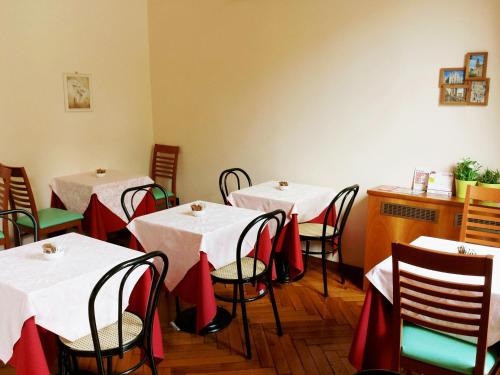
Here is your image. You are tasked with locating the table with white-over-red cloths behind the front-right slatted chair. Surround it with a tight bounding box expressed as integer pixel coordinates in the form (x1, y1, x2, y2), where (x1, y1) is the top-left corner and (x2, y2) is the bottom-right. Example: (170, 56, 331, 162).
(349, 236, 500, 370)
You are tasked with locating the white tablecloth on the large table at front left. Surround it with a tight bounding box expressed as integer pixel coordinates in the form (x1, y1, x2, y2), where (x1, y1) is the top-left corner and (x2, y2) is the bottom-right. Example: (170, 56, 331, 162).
(0, 233, 144, 363)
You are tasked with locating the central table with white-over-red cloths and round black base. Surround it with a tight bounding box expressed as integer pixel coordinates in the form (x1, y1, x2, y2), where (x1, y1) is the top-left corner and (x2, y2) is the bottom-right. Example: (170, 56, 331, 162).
(127, 201, 271, 334)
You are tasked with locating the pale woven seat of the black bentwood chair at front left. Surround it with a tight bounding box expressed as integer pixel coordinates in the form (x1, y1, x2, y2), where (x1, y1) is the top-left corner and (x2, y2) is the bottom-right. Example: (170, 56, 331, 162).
(59, 311, 143, 352)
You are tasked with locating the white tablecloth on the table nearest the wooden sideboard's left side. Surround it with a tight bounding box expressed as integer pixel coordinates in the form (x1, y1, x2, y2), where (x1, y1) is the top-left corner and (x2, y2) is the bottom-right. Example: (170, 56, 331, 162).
(228, 181, 335, 223)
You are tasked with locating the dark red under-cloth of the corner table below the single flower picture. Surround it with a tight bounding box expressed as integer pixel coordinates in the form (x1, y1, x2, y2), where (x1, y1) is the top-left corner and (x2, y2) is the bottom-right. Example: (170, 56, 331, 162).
(50, 192, 156, 241)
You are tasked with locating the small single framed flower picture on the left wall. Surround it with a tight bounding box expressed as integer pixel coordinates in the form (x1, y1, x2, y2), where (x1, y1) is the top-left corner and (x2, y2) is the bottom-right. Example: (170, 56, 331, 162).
(64, 73, 92, 112)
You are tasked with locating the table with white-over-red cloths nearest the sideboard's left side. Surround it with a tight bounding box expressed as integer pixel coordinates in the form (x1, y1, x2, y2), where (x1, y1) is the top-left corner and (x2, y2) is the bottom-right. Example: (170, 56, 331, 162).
(227, 181, 336, 281)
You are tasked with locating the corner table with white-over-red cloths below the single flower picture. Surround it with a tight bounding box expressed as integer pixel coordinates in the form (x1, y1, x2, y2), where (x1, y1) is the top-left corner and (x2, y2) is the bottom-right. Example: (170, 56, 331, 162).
(50, 169, 156, 241)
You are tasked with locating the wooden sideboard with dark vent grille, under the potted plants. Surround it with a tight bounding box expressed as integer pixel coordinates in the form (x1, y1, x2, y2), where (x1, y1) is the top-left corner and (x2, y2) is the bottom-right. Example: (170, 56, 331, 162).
(364, 186, 464, 288)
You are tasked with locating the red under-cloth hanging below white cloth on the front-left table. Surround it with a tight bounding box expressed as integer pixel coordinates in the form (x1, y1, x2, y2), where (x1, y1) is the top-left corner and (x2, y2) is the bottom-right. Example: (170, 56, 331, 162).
(8, 272, 163, 375)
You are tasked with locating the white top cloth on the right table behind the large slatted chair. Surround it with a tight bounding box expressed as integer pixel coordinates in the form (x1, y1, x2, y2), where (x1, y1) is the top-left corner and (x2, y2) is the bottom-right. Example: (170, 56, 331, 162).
(366, 236, 500, 345)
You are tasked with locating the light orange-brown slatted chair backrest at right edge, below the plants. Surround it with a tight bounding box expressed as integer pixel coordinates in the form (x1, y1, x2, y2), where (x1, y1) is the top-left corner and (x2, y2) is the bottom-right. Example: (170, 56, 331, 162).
(460, 186, 500, 247)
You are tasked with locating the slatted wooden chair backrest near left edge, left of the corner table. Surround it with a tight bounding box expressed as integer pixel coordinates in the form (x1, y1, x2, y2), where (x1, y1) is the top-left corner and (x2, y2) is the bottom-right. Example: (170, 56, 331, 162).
(7, 167, 39, 223)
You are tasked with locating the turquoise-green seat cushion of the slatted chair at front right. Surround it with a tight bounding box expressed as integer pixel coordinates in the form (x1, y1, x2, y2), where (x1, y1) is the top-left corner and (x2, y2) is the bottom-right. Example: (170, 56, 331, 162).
(401, 322, 500, 374)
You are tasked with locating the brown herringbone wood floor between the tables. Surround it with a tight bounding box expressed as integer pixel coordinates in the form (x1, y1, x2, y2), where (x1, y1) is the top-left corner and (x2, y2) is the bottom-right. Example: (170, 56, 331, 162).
(0, 262, 364, 375)
